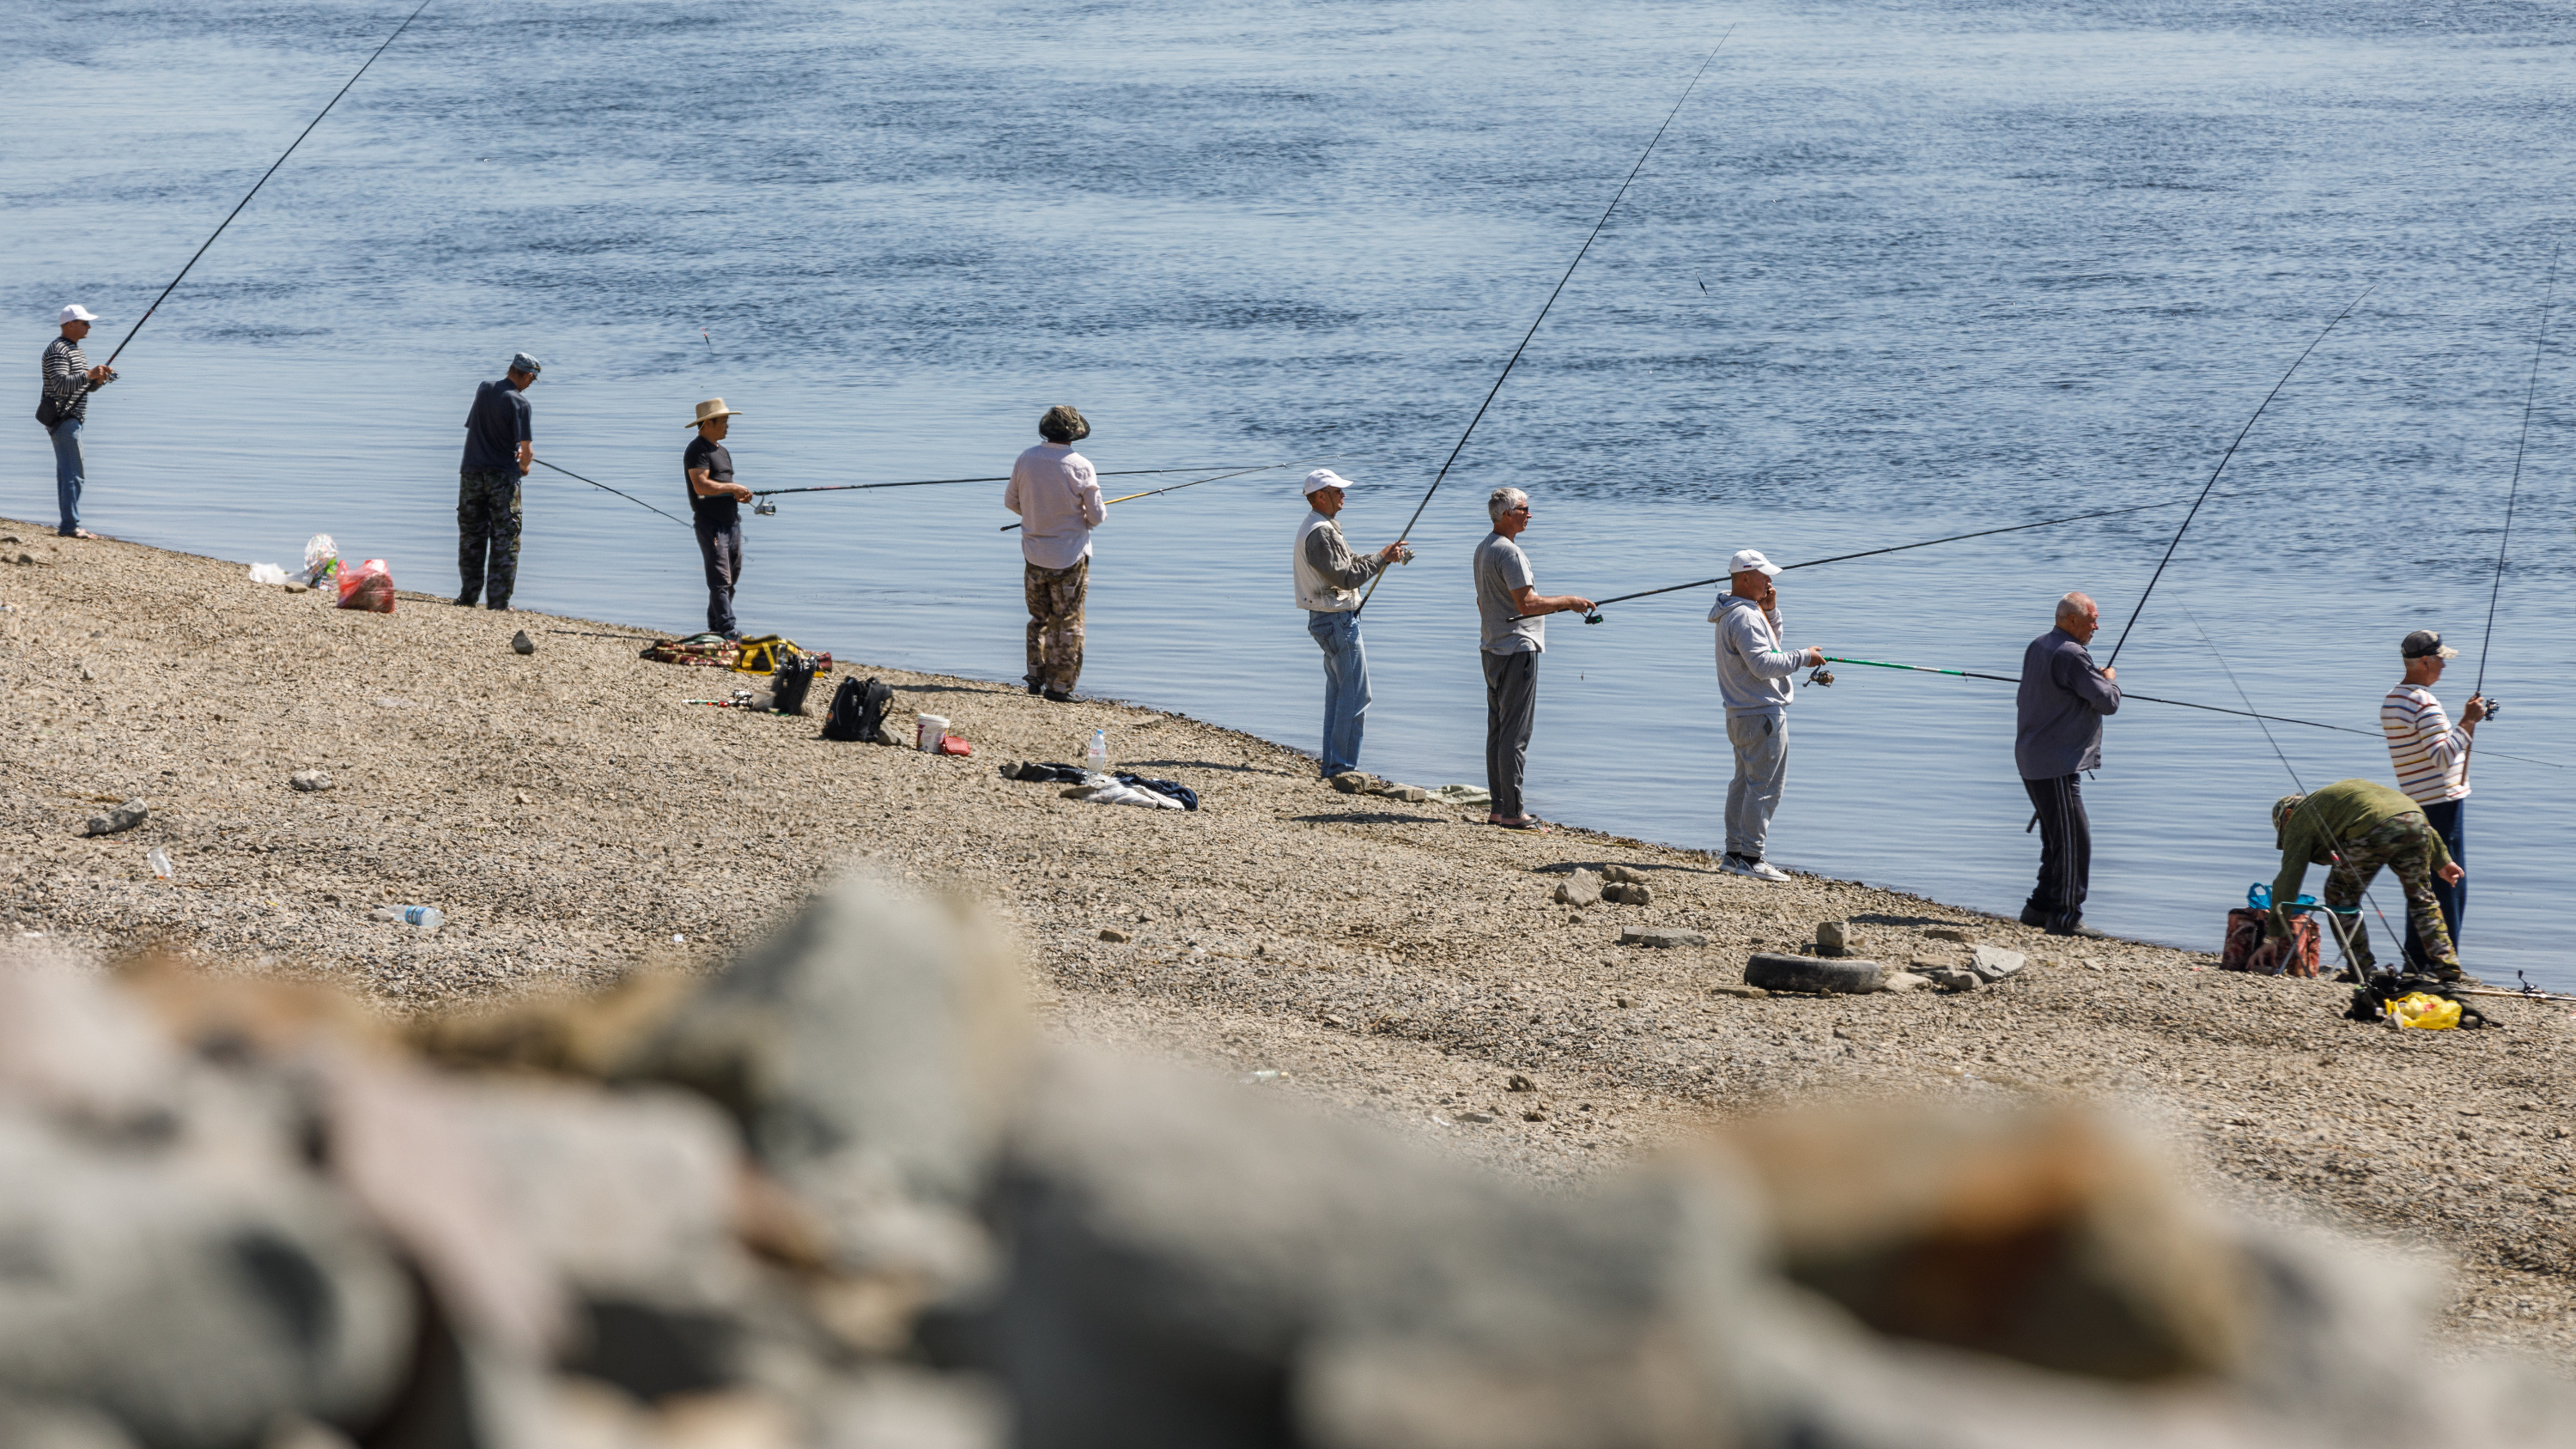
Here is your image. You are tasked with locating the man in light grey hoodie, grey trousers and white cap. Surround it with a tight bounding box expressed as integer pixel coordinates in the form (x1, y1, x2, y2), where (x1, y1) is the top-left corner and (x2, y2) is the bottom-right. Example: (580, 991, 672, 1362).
(1708, 549, 1824, 880)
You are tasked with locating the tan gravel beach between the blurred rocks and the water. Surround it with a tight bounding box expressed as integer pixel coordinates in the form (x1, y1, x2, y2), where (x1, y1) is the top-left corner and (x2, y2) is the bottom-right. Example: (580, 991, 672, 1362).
(0, 523, 2576, 1364)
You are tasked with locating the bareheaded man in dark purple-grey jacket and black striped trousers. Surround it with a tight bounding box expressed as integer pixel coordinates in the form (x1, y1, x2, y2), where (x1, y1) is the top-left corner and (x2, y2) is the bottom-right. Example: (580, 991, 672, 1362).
(2012, 595, 2120, 937)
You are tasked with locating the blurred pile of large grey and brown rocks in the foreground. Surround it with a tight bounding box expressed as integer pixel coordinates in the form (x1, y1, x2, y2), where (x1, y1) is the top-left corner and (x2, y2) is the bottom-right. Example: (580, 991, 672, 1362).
(0, 880, 2576, 1449)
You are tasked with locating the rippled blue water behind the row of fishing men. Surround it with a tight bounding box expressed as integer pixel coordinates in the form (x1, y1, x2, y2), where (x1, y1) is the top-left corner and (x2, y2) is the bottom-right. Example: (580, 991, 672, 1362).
(0, 0, 2576, 985)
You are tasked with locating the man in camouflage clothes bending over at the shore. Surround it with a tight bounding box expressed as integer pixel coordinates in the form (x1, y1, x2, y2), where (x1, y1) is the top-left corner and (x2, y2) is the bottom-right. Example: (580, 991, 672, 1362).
(2264, 779, 2468, 980)
